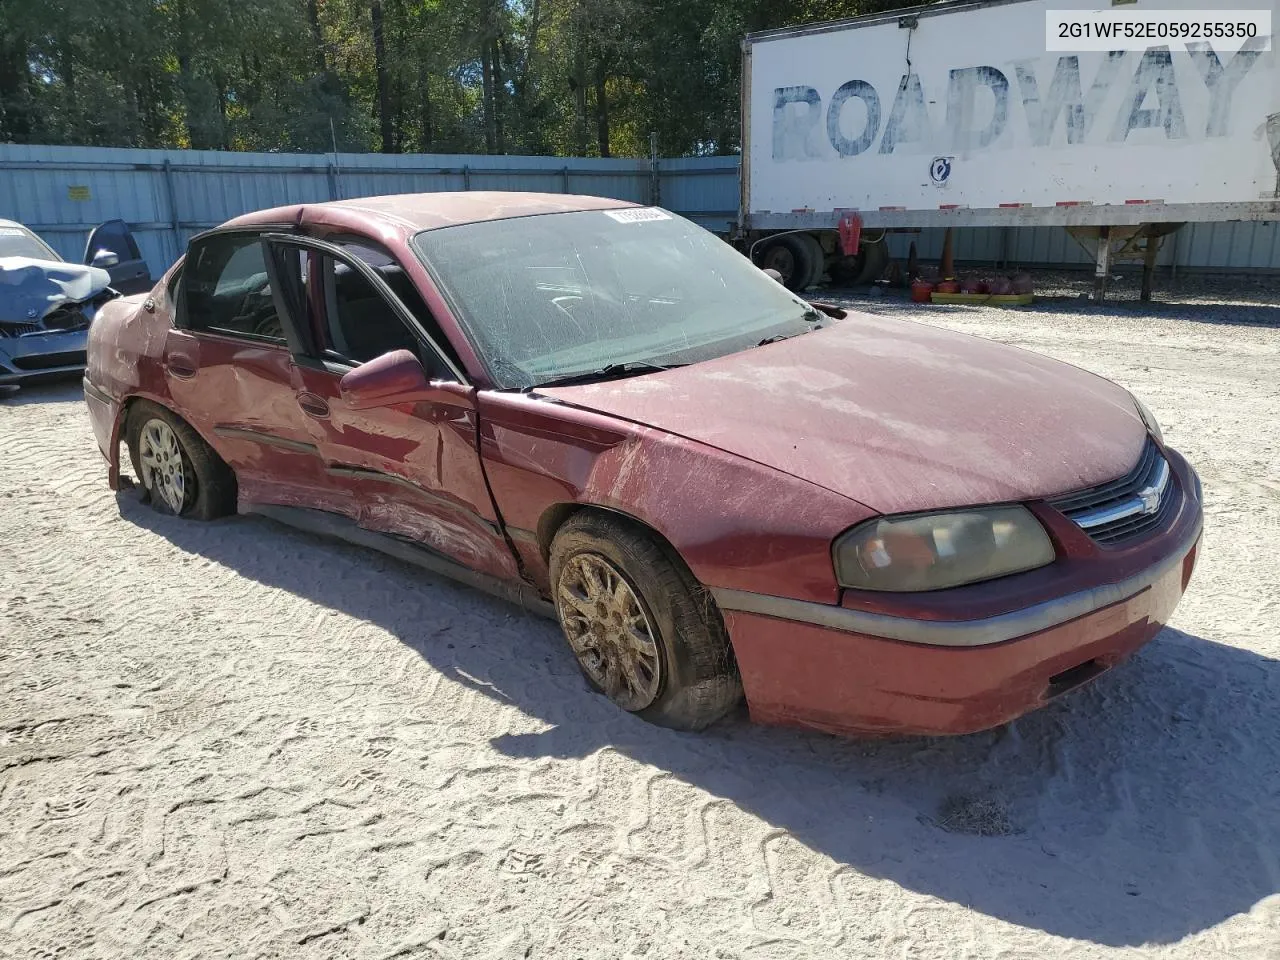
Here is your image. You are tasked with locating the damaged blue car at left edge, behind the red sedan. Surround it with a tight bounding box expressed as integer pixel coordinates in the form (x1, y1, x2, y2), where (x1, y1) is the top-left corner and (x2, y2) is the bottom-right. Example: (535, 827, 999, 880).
(0, 220, 151, 387)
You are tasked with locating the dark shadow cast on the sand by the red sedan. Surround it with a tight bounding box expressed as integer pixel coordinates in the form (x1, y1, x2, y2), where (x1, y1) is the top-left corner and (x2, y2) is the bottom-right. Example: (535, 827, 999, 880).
(119, 492, 1280, 946)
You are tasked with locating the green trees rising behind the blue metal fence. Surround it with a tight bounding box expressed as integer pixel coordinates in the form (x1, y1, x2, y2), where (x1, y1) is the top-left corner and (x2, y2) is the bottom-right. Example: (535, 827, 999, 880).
(0, 0, 910, 156)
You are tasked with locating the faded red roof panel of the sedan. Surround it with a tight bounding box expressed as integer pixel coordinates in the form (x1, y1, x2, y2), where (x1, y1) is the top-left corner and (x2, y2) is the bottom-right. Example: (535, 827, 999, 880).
(224, 191, 639, 233)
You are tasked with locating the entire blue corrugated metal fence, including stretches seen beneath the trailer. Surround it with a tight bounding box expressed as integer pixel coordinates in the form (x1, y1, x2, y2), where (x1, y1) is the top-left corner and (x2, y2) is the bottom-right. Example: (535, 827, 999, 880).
(0, 143, 1280, 275)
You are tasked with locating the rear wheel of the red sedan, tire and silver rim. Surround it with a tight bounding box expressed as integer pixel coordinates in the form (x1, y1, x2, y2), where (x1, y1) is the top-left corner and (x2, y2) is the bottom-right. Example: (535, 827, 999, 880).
(124, 401, 236, 520)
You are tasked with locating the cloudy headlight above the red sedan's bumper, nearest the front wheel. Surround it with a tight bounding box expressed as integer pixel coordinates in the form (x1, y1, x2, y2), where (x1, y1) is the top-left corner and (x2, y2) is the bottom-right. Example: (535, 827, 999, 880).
(835, 507, 1055, 593)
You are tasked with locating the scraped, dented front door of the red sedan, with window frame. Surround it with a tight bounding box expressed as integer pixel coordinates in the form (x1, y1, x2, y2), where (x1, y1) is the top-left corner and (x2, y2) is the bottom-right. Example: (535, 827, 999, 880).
(262, 241, 517, 579)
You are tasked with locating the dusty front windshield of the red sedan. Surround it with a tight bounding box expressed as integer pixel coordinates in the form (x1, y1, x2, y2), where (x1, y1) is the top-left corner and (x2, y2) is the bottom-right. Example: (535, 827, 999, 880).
(413, 207, 814, 389)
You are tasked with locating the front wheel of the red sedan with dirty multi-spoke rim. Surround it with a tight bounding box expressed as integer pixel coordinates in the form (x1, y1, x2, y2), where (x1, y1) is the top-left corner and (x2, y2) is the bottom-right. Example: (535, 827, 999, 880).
(550, 511, 742, 730)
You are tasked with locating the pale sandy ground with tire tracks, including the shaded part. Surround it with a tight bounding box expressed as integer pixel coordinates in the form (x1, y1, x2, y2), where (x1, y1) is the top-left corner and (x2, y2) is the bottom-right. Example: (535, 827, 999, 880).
(0, 288, 1280, 960)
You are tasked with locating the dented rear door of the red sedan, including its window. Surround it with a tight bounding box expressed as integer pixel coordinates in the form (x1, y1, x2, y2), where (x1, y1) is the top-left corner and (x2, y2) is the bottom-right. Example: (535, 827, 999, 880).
(164, 230, 348, 511)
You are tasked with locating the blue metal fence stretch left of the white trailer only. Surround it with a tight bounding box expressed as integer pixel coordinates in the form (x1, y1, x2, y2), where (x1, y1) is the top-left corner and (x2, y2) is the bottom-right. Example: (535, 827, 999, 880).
(0, 143, 737, 275)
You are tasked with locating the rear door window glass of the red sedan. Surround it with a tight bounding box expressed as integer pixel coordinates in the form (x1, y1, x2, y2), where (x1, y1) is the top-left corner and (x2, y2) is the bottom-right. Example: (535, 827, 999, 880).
(182, 234, 285, 343)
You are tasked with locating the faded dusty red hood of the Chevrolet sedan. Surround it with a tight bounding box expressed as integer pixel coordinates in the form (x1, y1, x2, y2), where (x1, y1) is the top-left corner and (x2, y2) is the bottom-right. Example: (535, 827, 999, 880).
(538, 314, 1146, 513)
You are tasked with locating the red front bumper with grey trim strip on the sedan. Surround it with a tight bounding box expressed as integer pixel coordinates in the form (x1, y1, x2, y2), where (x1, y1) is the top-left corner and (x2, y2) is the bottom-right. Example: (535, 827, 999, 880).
(713, 498, 1201, 735)
